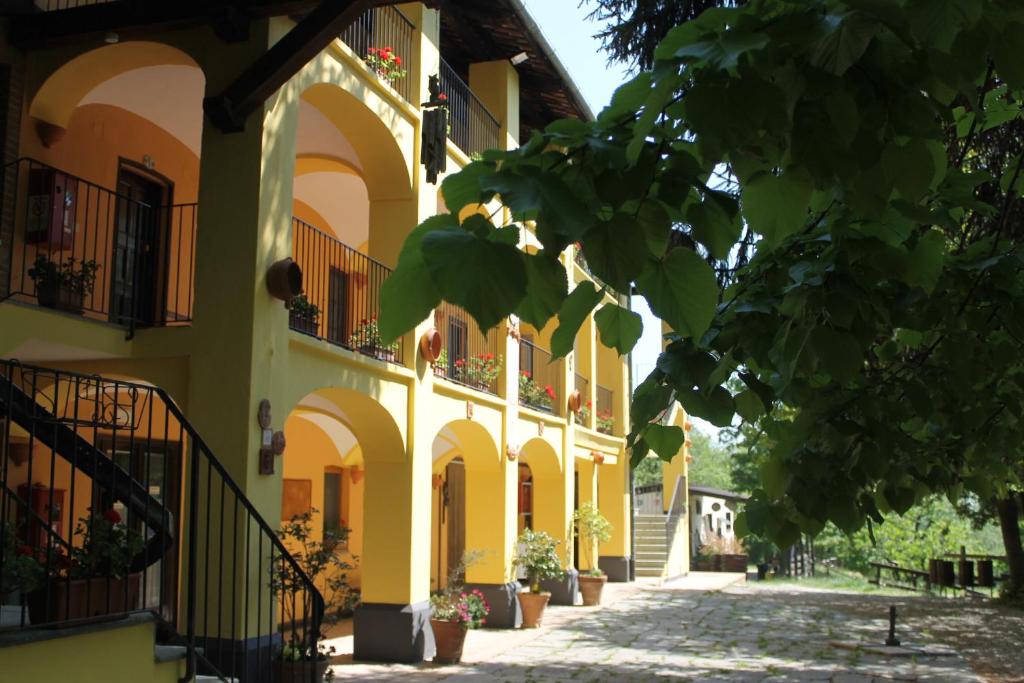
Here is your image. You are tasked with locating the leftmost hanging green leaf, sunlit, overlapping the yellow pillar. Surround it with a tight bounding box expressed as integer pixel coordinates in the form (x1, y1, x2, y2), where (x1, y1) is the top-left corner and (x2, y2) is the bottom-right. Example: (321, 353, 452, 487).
(378, 214, 459, 343)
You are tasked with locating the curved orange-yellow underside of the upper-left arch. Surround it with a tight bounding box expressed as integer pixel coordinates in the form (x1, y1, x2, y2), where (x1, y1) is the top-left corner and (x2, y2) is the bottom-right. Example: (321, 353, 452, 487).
(29, 41, 201, 128)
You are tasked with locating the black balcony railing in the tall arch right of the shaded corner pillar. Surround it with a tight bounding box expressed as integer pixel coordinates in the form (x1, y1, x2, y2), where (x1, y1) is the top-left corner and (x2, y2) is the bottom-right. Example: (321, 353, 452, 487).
(289, 218, 402, 362)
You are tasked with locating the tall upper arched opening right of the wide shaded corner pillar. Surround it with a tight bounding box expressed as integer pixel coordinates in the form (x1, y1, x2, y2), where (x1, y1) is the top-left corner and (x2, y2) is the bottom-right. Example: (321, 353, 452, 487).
(290, 83, 417, 361)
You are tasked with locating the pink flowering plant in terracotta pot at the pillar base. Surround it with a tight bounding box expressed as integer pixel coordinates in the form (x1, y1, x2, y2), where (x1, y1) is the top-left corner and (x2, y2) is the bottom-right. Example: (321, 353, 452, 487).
(430, 551, 490, 664)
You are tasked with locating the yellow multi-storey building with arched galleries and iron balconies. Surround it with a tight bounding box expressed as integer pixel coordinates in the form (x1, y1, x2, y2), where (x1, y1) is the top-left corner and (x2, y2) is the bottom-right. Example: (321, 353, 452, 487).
(0, 0, 632, 681)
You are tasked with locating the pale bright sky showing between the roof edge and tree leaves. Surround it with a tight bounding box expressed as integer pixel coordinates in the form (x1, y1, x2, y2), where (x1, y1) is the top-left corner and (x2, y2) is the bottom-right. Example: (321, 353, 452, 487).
(523, 0, 719, 436)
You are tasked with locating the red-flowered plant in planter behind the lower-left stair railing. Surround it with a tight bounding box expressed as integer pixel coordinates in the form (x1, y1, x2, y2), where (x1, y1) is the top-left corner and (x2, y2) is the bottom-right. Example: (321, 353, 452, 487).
(29, 508, 143, 624)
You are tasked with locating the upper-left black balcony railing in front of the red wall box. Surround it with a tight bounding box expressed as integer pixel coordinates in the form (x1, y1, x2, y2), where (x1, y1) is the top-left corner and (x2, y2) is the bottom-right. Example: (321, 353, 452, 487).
(0, 159, 199, 329)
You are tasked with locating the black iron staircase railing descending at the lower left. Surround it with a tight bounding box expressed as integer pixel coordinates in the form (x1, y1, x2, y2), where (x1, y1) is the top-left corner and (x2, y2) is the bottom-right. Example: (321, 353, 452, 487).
(0, 360, 324, 683)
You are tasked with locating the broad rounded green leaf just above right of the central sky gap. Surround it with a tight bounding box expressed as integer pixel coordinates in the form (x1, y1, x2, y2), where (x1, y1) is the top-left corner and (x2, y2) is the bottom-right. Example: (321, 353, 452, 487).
(637, 248, 718, 339)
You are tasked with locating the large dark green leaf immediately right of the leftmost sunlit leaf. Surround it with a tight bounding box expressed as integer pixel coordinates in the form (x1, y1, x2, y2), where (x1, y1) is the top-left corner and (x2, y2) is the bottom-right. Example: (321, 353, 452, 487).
(423, 229, 526, 331)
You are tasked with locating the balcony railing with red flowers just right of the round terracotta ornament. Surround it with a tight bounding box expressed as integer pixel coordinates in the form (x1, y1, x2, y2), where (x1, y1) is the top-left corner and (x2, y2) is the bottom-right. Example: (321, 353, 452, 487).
(434, 301, 505, 395)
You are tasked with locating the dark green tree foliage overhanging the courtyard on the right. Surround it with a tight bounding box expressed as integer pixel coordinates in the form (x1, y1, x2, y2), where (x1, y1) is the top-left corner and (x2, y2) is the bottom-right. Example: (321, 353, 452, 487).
(381, 0, 1024, 589)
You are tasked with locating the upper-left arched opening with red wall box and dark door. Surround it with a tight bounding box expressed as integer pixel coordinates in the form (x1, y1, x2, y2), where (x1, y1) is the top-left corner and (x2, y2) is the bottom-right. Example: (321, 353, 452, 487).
(11, 41, 206, 328)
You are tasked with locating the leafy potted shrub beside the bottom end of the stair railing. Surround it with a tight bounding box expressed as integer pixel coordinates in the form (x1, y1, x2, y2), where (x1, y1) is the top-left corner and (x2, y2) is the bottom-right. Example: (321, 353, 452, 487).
(270, 508, 358, 683)
